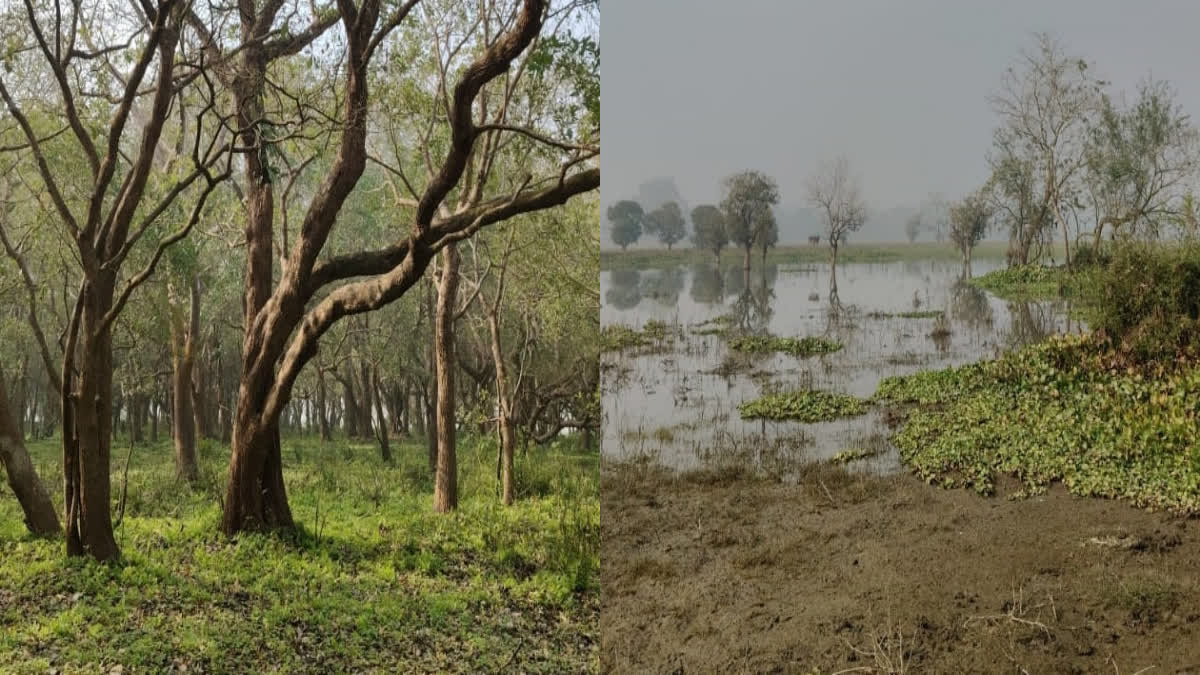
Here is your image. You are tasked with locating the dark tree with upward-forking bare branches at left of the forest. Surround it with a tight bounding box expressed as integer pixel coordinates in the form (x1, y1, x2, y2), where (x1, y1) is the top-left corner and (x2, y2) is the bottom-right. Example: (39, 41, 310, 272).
(0, 0, 230, 561)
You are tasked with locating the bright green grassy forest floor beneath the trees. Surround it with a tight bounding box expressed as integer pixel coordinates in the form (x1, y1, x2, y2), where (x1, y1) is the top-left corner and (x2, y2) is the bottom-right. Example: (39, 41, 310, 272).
(0, 438, 599, 674)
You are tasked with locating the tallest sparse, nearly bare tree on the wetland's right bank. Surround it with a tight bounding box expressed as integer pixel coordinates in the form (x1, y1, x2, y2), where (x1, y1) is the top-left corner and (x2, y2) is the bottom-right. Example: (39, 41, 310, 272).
(991, 32, 1103, 269)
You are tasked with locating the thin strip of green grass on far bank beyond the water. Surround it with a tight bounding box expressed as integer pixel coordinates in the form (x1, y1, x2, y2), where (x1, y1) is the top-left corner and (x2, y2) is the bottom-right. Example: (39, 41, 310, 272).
(600, 241, 1008, 269)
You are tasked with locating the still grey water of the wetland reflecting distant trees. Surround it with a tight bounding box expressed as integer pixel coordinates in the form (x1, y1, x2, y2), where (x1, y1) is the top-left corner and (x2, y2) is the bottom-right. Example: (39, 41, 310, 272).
(600, 259, 1082, 472)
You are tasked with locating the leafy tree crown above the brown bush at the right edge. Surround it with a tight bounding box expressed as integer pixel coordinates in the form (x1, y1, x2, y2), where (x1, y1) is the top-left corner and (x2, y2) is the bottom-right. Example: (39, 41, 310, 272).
(1084, 80, 1200, 246)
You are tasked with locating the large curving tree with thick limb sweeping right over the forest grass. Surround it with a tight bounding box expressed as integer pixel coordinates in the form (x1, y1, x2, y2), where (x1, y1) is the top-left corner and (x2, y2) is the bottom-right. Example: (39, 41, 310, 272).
(218, 0, 600, 533)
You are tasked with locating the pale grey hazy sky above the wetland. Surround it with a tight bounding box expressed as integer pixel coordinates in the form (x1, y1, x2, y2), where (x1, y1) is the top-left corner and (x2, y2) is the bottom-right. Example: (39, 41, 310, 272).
(601, 0, 1200, 208)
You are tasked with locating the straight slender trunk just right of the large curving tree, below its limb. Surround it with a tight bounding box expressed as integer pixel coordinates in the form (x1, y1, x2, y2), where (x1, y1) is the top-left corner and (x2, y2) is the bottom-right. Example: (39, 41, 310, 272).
(433, 244, 460, 513)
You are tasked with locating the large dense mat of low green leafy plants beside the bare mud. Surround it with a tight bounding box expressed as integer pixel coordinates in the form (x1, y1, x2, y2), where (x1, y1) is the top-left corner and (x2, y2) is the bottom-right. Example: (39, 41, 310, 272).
(875, 336, 1200, 513)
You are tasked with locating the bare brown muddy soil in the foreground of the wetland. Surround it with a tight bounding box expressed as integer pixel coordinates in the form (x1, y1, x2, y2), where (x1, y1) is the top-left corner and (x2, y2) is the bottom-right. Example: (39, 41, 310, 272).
(600, 465, 1200, 675)
